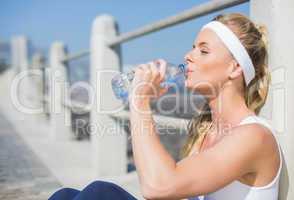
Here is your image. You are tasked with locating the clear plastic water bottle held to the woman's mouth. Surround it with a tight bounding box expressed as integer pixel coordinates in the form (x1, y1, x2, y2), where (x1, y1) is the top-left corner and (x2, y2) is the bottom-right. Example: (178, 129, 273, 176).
(111, 63, 186, 103)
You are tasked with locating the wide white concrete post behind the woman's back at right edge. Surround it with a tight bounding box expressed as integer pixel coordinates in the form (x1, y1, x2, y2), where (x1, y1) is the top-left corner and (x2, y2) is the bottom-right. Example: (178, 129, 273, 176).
(250, 0, 294, 200)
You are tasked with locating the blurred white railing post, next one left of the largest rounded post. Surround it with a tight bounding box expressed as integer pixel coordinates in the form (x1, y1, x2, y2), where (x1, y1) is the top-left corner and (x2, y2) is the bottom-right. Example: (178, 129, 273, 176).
(47, 42, 72, 140)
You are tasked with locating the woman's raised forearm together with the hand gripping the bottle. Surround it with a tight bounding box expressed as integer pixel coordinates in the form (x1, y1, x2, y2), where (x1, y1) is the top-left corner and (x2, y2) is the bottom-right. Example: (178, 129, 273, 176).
(130, 61, 176, 195)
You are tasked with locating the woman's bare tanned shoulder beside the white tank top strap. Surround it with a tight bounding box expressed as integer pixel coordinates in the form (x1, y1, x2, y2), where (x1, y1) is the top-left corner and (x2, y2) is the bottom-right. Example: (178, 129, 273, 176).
(227, 123, 281, 186)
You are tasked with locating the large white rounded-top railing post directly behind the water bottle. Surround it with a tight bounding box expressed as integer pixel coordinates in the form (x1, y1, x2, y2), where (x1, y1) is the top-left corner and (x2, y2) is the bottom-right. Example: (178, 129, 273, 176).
(90, 15, 127, 177)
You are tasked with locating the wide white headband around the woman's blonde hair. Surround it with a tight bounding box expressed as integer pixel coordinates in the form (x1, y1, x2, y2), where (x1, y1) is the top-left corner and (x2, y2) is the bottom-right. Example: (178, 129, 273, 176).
(202, 21, 255, 85)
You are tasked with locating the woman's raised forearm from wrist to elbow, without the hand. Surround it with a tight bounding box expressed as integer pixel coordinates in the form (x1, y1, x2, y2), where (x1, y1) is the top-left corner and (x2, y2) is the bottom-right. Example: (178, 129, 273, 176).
(130, 96, 176, 197)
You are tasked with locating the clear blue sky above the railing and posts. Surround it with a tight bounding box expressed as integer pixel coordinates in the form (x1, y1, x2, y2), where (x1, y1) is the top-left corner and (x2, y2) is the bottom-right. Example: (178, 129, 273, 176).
(0, 0, 249, 64)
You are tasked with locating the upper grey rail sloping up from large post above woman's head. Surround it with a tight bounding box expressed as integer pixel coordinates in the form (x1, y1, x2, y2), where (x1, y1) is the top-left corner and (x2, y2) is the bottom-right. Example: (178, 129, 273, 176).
(108, 0, 249, 46)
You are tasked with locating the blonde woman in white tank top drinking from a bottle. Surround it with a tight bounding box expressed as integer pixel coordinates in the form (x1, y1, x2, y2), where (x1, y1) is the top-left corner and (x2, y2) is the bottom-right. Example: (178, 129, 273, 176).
(52, 14, 282, 200)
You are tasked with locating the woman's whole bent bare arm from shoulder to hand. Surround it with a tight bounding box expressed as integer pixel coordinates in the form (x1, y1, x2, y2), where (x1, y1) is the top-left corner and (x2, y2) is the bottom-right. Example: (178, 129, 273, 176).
(130, 59, 274, 200)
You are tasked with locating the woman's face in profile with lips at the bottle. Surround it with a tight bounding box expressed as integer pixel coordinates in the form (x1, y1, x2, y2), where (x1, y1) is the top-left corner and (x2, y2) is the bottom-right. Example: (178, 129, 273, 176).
(185, 29, 233, 95)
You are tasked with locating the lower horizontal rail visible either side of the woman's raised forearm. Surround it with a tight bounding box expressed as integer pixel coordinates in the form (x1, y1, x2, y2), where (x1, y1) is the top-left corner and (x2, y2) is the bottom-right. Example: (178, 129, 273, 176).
(110, 110, 189, 130)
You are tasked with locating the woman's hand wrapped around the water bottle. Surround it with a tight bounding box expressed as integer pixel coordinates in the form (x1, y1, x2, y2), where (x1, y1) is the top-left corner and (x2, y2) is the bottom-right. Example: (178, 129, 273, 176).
(129, 59, 168, 107)
